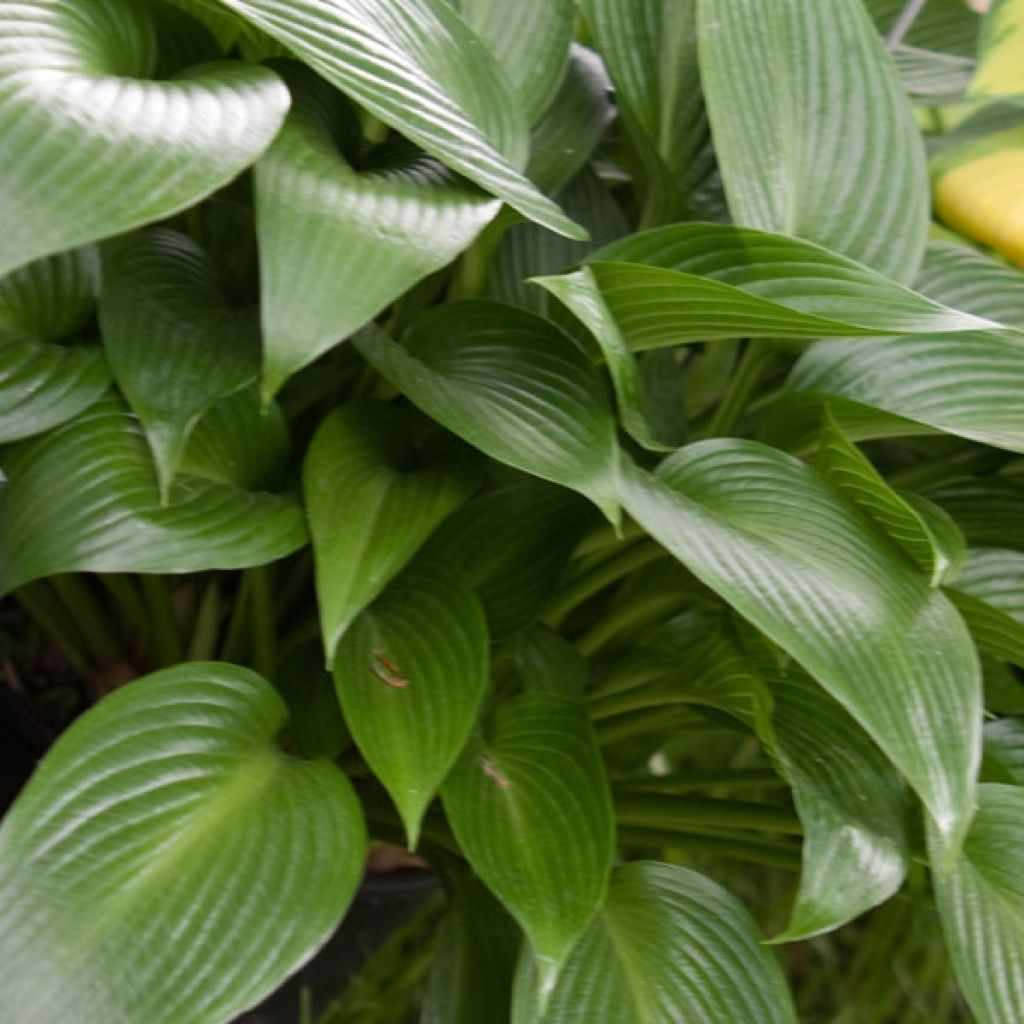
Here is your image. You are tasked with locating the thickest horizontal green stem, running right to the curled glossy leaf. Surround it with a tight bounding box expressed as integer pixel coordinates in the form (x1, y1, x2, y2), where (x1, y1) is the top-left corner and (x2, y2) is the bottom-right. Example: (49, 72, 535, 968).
(614, 791, 804, 836)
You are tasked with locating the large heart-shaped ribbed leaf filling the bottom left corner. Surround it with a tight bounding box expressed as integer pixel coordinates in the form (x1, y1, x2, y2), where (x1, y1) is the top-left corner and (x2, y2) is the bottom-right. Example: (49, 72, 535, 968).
(0, 663, 367, 1024)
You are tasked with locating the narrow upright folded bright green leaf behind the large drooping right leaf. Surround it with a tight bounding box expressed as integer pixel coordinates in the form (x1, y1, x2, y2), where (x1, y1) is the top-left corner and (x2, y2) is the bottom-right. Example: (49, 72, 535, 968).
(818, 413, 963, 587)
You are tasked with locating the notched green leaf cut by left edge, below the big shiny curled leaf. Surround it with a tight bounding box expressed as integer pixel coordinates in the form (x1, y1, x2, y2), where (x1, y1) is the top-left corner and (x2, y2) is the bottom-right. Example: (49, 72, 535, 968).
(0, 248, 111, 443)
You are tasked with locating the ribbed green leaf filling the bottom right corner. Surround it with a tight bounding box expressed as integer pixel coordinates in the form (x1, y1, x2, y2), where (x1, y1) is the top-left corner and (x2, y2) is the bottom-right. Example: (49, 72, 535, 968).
(929, 783, 1024, 1024)
